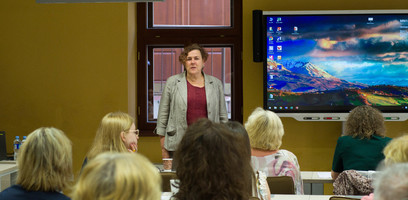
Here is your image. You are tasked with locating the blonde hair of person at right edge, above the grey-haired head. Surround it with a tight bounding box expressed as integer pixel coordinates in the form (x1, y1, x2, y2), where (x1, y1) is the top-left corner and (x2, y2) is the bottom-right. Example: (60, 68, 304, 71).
(384, 134, 408, 166)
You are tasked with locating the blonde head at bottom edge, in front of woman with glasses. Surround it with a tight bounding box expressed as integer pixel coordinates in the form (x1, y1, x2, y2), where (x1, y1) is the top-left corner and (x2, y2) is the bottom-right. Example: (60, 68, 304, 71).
(71, 152, 161, 200)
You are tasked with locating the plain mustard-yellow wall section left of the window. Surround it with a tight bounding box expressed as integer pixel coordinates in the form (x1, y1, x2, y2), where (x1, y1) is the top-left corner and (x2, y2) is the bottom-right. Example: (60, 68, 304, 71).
(0, 0, 129, 177)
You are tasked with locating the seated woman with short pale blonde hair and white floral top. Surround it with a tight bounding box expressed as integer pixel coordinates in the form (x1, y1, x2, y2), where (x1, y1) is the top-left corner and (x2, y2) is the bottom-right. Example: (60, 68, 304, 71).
(245, 108, 303, 194)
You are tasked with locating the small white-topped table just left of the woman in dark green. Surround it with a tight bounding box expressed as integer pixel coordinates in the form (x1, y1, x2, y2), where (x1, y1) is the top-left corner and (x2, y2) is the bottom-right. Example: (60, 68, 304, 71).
(300, 171, 333, 195)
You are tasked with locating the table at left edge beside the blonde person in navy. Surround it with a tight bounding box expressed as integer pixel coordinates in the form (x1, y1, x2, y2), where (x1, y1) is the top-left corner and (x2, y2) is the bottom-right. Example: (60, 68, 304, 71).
(0, 161, 18, 192)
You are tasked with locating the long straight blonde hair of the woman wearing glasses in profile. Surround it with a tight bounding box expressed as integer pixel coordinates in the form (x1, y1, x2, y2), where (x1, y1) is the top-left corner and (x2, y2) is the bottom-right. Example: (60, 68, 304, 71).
(87, 112, 134, 160)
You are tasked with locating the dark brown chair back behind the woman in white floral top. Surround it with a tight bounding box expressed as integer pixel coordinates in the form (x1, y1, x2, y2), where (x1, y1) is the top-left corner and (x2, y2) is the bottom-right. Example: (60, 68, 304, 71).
(266, 176, 295, 194)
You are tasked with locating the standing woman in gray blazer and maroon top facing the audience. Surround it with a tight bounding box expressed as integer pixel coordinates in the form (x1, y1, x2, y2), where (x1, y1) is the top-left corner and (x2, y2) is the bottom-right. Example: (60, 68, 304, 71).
(155, 44, 228, 168)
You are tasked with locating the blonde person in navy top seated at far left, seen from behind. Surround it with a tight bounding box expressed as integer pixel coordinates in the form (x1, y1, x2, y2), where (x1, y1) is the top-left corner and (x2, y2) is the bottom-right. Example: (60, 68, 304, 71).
(0, 128, 73, 200)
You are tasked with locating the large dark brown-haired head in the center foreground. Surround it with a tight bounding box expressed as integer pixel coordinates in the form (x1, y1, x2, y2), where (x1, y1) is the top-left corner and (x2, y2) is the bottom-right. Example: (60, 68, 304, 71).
(174, 118, 253, 200)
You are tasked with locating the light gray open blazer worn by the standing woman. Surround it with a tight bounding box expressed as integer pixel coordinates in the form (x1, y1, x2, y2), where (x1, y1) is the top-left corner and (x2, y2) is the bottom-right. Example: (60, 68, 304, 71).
(155, 72, 228, 151)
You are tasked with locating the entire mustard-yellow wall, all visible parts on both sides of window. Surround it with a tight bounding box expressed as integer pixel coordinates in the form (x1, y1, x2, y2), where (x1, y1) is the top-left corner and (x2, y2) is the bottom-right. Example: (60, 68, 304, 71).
(0, 0, 408, 188)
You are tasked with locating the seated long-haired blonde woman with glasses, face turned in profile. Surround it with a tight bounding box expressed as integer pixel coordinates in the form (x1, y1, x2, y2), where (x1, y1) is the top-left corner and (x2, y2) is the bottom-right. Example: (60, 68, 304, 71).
(82, 112, 139, 167)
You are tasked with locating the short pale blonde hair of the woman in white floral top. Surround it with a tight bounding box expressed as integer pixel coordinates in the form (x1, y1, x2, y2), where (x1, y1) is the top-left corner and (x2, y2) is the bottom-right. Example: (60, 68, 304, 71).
(245, 107, 284, 150)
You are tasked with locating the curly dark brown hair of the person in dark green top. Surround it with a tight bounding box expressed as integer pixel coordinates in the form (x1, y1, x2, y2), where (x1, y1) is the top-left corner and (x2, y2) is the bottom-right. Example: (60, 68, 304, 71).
(345, 105, 385, 139)
